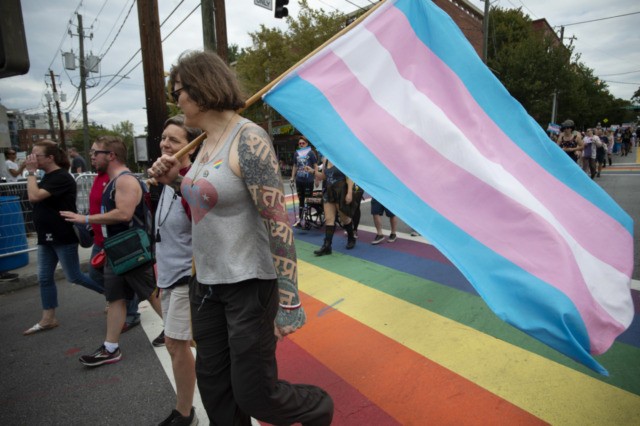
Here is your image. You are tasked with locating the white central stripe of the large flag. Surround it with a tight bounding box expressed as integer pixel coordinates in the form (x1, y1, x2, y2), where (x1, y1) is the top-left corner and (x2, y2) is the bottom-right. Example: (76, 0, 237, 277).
(333, 26, 633, 326)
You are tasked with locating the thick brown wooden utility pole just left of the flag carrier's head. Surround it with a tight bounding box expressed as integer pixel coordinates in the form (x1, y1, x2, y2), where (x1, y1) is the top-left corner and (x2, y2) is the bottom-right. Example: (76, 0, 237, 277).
(137, 0, 167, 163)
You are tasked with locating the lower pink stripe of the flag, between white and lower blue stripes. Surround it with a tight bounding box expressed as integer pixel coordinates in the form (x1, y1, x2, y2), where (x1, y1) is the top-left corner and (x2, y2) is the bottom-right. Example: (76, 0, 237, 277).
(300, 53, 624, 351)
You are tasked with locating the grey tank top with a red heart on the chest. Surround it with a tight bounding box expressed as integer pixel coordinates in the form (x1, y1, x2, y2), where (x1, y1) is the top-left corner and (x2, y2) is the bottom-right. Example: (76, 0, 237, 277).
(181, 119, 276, 284)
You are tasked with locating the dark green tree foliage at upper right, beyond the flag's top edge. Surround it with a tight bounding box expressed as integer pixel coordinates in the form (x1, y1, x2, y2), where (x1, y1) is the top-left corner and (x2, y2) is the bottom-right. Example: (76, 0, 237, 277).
(487, 7, 629, 129)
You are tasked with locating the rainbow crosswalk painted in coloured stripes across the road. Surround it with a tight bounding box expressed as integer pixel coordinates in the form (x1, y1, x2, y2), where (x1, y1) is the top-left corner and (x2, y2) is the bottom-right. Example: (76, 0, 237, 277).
(278, 231, 640, 425)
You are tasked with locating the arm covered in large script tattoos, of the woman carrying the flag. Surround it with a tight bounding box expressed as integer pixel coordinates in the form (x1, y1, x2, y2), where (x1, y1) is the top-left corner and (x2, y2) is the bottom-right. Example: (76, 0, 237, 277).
(237, 124, 306, 337)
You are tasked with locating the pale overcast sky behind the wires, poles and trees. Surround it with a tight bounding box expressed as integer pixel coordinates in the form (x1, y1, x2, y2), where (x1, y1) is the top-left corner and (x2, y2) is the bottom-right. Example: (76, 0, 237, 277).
(0, 0, 640, 134)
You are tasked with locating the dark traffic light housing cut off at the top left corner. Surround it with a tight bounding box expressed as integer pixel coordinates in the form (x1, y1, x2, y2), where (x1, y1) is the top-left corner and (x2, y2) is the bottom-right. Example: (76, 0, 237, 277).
(0, 0, 30, 78)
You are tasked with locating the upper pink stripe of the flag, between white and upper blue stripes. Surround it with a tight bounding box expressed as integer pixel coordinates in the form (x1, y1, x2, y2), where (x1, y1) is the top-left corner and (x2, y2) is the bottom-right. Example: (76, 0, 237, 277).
(366, 8, 633, 275)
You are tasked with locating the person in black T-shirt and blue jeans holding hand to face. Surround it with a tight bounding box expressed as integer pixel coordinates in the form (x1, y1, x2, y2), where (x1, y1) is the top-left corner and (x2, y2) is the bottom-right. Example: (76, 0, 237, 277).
(23, 140, 104, 335)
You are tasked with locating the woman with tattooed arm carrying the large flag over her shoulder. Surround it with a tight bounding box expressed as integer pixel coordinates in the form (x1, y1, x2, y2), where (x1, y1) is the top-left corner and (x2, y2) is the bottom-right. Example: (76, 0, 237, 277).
(149, 51, 333, 426)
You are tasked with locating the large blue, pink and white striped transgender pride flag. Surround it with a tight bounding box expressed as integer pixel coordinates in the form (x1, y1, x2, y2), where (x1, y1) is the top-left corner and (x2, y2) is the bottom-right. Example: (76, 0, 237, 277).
(264, 0, 633, 374)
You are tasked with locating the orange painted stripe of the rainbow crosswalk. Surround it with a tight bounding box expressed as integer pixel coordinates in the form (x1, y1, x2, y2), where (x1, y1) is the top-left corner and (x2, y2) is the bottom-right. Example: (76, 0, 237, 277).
(290, 292, 545, 425)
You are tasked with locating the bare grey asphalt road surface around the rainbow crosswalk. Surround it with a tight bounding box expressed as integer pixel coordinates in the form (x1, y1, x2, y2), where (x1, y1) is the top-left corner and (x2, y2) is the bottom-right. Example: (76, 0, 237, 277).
(0, 152, 640, 425)
